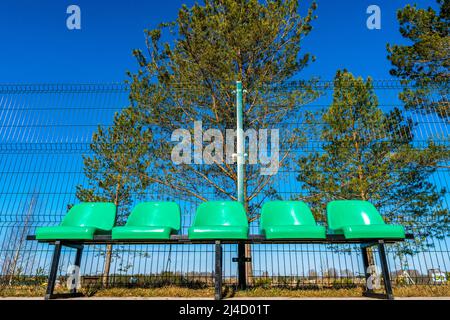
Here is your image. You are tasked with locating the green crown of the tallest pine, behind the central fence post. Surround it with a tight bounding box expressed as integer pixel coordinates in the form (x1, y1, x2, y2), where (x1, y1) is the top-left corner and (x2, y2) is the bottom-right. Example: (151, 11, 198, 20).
(129, 0, 317, 220)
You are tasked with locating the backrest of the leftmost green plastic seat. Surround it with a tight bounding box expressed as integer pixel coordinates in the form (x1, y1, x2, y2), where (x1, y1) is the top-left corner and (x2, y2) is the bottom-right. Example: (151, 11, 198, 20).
(61, 202, 116, 231)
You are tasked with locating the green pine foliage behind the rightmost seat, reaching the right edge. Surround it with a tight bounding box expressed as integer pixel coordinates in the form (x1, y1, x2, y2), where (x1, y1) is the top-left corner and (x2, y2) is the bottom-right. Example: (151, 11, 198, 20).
(298, 71, 449, 242)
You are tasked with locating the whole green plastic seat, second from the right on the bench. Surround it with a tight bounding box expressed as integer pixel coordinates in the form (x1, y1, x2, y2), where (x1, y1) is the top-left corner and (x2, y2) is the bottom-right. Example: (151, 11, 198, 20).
(260, 201, 326, 240)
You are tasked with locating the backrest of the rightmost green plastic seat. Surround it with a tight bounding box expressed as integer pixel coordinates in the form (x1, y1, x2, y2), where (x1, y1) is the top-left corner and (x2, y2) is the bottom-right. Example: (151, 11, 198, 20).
(327, 200, 385, 230)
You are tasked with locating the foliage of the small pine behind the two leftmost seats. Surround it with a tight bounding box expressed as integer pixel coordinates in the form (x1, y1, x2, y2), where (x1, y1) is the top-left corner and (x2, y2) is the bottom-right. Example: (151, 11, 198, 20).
(77, 108, 152, 220)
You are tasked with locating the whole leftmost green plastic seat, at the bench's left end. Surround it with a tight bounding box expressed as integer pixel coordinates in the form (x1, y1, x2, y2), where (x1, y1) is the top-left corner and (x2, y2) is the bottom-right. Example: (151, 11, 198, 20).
(36, 202, 116, 240)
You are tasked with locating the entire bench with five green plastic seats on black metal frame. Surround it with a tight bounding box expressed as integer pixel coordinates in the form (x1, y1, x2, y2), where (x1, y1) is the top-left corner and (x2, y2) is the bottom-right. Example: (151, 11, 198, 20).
(27, 200, 413, 300)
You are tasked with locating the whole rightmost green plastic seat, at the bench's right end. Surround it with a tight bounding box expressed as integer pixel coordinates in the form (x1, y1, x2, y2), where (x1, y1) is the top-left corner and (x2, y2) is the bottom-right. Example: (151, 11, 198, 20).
(327, 200, 405, 239)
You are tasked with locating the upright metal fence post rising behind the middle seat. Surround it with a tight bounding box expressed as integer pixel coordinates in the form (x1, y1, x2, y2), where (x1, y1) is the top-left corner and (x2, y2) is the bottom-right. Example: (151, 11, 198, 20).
(236, 81, 247, 290)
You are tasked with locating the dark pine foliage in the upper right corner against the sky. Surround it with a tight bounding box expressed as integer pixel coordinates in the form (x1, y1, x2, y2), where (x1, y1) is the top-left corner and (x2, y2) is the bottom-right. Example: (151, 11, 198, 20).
(388, 0, 450, 119)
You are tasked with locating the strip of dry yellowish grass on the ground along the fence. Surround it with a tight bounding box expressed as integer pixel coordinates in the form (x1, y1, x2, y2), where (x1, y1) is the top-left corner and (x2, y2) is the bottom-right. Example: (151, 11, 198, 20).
(0, 285, 450, 298)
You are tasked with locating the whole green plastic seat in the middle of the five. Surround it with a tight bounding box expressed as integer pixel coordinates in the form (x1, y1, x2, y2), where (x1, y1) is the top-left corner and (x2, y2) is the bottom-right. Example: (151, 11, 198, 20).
(188, 201, 248, 240)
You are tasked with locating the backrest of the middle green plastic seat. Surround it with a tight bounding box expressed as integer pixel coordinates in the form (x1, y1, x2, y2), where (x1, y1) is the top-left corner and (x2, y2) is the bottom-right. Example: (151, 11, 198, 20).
(193, 201, 248, 227)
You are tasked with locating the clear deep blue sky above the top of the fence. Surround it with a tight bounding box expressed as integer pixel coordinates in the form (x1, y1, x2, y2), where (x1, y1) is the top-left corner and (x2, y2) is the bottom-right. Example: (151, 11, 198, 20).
(0, 0, 435, 83)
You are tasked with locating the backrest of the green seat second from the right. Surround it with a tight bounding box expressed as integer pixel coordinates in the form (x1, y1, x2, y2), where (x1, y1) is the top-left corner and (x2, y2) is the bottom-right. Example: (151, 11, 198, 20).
(260, 201, 317, 230)
